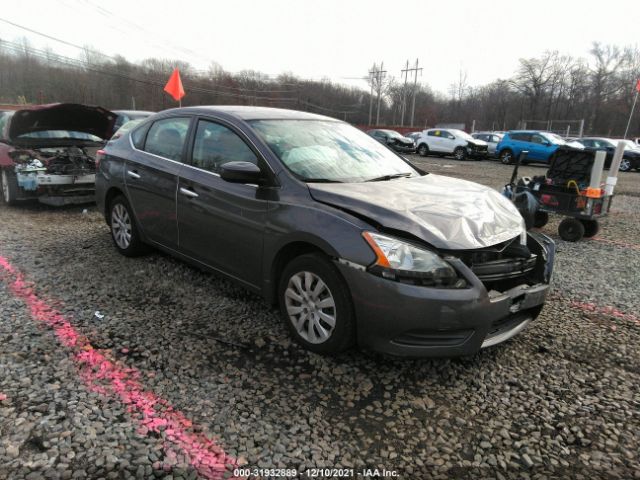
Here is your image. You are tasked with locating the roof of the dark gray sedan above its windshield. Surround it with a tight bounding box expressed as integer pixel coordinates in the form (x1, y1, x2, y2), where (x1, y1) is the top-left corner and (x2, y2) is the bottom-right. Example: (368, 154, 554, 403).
(161, 105, 341, 122)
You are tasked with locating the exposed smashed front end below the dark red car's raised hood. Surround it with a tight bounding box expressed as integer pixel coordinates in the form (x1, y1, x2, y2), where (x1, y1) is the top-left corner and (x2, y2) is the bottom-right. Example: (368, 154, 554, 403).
(9, 146, 97, 206)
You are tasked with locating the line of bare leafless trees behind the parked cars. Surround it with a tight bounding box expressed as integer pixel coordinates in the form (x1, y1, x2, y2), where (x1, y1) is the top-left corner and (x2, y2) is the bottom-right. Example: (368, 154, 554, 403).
(0, 39, 640, 136)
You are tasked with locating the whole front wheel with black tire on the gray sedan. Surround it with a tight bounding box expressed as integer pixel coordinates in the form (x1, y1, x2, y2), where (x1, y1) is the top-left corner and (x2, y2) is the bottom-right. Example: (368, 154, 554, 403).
(278, 253, 356, 355)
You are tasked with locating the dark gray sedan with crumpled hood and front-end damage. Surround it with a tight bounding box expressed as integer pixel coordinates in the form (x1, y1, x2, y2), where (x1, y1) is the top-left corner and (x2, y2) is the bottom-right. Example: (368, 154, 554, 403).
(96, 107, 555, 356)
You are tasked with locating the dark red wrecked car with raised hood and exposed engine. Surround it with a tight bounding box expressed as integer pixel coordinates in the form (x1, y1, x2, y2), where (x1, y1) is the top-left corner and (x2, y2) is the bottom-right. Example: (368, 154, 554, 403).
(0, 103, 116, 205)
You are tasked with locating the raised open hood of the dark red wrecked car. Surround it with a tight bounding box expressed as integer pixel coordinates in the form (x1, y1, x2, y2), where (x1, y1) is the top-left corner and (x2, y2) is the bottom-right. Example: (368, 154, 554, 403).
(7, 103, 116, 142)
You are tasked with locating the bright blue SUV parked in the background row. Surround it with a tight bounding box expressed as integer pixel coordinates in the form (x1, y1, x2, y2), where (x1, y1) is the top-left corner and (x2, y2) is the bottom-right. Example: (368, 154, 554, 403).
(496, 130, 567, 165)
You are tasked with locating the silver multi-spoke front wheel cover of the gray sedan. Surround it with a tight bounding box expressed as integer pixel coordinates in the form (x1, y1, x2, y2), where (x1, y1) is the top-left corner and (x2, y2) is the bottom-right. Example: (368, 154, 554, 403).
(285, 271, 336, 344)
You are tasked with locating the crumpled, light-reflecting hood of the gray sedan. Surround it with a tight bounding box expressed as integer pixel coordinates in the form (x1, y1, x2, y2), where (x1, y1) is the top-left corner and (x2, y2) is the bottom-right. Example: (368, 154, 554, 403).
(308, 174, 524, 250)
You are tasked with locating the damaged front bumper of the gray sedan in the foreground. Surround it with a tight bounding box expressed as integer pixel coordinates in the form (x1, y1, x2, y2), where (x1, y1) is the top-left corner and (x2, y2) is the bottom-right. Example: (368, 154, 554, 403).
(337, 231, 555, 357)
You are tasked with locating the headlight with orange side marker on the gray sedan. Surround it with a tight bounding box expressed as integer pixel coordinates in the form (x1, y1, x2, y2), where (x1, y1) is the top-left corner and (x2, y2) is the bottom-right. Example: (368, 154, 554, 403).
(363, 232, 466, 288)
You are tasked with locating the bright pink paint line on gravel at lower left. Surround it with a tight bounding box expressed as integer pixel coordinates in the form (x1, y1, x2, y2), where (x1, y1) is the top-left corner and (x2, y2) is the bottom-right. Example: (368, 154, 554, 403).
(0, 256, 238, 479)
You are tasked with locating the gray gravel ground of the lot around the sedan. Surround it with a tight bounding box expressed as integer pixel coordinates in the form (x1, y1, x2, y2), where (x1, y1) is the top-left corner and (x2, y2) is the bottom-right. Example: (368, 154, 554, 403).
(0, 156, 640, 479)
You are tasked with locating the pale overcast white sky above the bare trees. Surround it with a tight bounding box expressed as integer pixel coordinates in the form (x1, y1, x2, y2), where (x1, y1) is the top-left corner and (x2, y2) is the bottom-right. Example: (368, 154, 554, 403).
(0, 0, 640, 94)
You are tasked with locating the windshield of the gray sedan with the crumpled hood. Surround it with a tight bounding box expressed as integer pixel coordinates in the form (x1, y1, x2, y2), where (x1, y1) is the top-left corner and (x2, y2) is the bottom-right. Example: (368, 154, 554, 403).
(250, 120, 418, 182)
